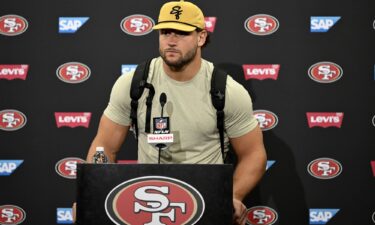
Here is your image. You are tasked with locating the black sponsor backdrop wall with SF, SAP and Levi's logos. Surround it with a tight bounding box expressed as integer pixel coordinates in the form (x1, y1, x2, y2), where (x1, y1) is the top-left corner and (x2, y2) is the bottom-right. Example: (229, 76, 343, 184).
(0, 0, 375, 225)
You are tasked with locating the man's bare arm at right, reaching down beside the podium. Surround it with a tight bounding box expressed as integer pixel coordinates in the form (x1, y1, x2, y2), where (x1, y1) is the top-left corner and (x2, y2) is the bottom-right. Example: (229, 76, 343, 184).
(230, 126, 267, 224)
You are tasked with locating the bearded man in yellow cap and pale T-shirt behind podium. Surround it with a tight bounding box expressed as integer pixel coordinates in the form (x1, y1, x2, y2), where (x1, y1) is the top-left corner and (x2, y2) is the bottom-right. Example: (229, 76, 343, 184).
(80, 1, 266, 225)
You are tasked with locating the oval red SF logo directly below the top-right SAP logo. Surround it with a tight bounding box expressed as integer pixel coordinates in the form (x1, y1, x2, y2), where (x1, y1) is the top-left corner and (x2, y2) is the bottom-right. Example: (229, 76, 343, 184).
(308, 62, 343, 83)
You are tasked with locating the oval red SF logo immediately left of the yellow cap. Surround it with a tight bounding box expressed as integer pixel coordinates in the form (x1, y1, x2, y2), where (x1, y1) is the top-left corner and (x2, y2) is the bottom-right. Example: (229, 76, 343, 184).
(120, 14, 155, 36)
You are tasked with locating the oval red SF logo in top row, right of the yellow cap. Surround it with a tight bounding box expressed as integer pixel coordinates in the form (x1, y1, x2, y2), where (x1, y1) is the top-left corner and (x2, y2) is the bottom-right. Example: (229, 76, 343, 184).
(245, 14, 279, 36)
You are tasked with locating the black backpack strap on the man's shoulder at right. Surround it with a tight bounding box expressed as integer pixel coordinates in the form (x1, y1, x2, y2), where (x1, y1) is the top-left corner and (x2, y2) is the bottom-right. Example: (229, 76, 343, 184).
(210, 67, 227, 162)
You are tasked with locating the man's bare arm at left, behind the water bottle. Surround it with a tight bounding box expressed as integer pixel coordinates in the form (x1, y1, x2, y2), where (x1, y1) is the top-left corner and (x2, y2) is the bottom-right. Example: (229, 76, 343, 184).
(86, 114, 129, 163)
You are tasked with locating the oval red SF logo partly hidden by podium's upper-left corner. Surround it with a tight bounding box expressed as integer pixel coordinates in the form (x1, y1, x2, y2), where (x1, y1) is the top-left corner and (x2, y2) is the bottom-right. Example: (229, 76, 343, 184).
(55, 157, 86, 179)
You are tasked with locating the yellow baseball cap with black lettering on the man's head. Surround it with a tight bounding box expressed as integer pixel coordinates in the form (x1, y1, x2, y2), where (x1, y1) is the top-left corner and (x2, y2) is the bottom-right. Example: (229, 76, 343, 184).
(152, 0, 205, 32)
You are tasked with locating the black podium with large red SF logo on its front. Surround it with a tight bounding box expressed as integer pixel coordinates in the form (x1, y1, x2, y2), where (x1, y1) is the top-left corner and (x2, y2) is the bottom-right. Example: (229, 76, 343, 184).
(76, 164, 233, 225)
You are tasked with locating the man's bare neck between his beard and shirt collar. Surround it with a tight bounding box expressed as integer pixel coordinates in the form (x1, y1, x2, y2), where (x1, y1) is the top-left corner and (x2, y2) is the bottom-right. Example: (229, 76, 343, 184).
(163, 57, 202, 81)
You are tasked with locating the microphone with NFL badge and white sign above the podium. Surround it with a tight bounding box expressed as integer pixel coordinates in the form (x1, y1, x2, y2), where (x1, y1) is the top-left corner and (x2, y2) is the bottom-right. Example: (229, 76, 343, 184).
(147, 92, 173, 164)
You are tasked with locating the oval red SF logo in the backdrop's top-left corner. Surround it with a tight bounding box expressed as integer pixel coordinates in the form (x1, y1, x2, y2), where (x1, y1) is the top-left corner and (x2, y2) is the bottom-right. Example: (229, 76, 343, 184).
(0, 15, 28, 36)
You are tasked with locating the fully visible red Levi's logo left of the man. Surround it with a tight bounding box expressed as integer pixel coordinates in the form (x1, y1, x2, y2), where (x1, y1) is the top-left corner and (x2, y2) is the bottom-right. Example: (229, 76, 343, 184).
(55, 112, 91, 128)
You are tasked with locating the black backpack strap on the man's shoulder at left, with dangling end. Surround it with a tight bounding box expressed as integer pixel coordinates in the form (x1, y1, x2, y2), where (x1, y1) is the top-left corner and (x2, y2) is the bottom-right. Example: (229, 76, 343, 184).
(130, 59, 155, 139)
